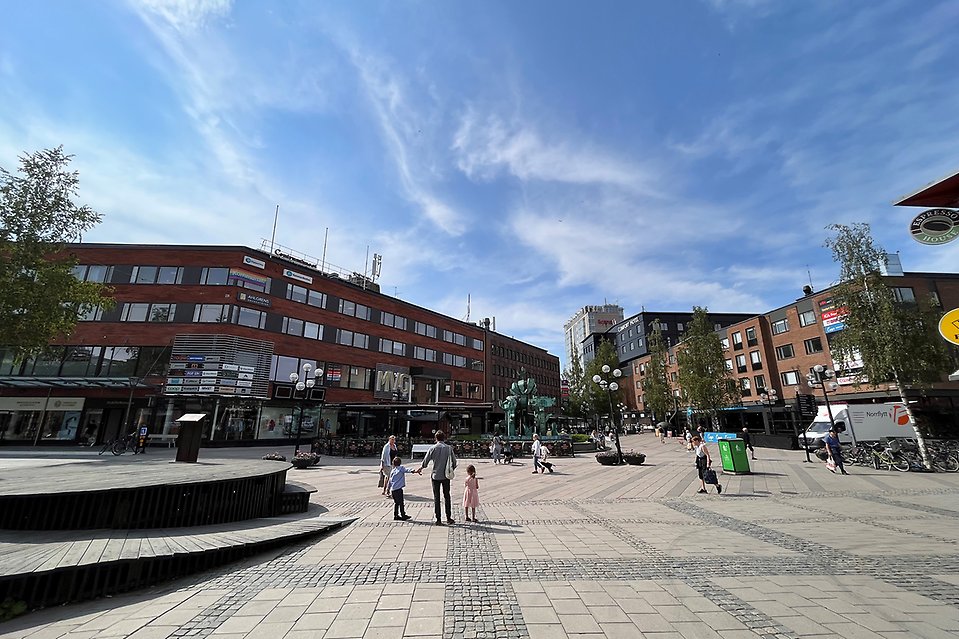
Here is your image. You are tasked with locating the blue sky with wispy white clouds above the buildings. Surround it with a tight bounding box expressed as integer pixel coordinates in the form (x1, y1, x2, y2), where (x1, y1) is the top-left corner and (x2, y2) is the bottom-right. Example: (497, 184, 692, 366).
(0, 0, 959, 364)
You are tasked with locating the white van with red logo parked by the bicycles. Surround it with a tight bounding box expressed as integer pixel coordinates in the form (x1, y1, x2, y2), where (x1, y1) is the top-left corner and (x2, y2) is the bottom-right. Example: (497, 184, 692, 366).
(800, 402, 916, 449)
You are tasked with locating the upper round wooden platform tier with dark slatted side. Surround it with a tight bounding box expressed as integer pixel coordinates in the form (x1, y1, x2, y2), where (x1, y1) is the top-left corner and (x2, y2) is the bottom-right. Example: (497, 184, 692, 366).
(0, 457, 309, 530)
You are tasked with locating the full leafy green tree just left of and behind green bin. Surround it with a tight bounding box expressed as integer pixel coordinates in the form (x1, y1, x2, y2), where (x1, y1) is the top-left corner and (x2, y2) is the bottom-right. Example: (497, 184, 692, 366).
(677, 306, 740, 428)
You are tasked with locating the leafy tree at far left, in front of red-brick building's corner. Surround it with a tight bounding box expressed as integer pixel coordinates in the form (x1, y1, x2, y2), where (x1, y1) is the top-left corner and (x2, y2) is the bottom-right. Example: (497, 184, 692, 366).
(0, 147, 110, 360)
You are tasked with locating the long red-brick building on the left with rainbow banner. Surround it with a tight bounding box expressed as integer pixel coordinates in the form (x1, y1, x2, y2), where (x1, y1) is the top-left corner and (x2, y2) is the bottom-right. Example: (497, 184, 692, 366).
(0, 244, 559, 443)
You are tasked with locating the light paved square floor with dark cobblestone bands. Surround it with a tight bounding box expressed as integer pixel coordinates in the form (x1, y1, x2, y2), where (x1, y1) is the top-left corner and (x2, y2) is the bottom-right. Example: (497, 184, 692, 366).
(0, 435, 959, 639)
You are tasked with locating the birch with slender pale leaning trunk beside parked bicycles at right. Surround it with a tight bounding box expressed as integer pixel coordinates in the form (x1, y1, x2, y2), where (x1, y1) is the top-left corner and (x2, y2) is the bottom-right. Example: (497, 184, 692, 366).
(825, 223, 952, 468)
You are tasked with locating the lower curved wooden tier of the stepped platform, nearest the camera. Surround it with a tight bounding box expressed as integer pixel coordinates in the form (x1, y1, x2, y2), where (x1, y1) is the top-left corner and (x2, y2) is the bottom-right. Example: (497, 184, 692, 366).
(0, 506, 354, 608)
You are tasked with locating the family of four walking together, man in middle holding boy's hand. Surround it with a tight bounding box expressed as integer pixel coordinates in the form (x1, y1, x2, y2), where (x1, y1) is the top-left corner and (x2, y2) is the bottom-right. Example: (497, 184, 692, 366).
(380, 430, 479, 526)
